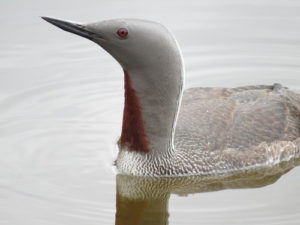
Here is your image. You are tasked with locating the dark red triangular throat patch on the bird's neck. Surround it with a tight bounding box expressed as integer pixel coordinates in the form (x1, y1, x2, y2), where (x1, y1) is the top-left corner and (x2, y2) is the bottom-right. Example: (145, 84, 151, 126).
(119, 71, 149, 153)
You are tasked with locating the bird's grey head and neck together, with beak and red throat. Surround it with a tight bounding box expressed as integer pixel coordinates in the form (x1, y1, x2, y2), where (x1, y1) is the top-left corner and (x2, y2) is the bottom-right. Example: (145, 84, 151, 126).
(43, 17, 184, 155)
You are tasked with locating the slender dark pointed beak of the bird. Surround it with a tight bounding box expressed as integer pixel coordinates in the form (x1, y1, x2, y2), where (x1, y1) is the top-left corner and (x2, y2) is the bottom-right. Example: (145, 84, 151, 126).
(42, 17, 103, 41)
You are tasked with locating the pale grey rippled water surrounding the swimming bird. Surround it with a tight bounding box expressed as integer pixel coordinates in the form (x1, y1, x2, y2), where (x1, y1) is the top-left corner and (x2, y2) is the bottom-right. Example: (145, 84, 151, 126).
(0, 0, 300, 225)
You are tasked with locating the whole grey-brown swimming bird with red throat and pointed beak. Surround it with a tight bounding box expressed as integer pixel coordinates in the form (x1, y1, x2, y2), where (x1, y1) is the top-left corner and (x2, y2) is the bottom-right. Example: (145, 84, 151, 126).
(42, 17, 300, 177)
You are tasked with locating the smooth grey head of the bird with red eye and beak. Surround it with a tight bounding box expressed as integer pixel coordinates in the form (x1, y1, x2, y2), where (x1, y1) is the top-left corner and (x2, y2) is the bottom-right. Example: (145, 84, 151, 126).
(42, 17, 180, 70)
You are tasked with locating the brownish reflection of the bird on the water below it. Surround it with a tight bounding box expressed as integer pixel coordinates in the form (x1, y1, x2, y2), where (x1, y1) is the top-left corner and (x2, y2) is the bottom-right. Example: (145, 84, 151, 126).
(115, 159, 300, 225)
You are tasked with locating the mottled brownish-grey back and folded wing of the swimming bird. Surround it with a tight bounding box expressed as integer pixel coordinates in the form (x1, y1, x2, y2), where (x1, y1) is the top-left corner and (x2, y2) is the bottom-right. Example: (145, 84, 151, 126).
(175, 84, 300, 151)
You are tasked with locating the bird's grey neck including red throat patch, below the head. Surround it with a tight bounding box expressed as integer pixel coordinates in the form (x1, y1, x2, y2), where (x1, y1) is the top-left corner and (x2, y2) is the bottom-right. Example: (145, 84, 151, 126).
(119, 65, 183, 155)
